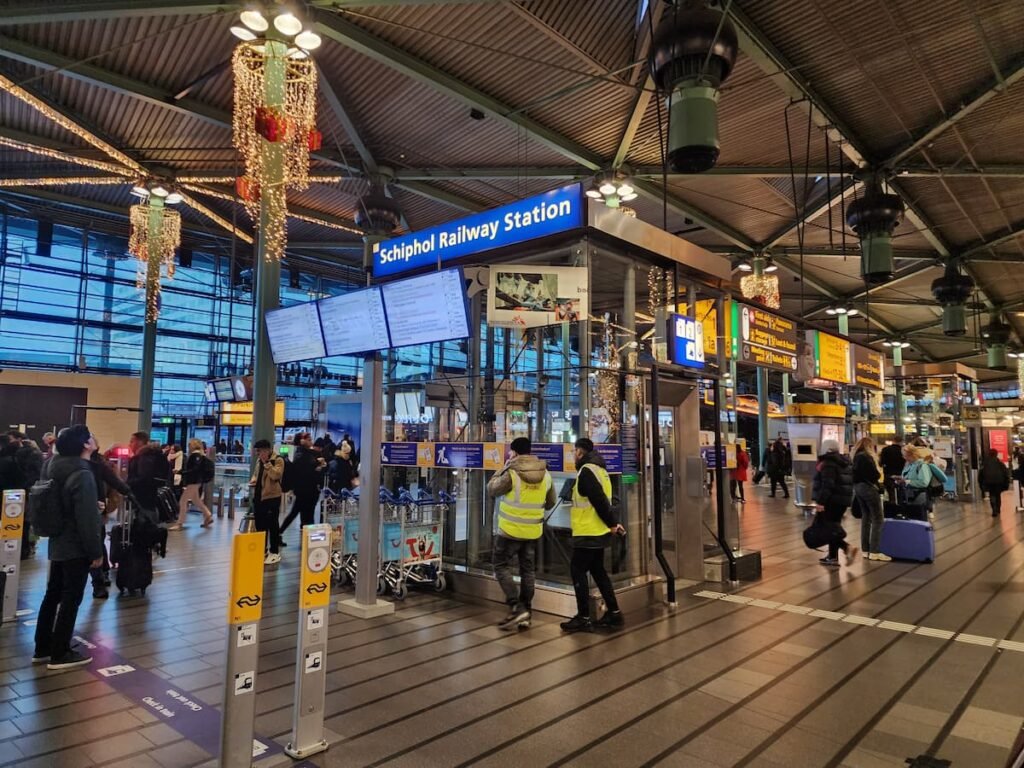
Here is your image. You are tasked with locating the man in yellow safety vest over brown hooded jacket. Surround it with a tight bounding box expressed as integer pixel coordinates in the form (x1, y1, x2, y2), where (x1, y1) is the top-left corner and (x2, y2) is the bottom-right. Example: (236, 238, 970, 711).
(487, 437, 557, 631)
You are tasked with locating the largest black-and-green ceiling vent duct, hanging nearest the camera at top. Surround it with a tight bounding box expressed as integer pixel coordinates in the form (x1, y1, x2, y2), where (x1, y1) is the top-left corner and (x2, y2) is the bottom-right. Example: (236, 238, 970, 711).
(653, 0, 739, 173)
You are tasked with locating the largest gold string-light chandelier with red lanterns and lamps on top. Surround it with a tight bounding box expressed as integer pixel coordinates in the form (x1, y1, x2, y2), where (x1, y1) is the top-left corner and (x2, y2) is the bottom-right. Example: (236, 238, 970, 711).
(231, 6, 323, 261)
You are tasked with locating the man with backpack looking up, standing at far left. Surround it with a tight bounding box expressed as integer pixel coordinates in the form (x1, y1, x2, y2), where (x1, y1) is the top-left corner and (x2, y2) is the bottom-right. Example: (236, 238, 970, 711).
(32, 424, 103, 670)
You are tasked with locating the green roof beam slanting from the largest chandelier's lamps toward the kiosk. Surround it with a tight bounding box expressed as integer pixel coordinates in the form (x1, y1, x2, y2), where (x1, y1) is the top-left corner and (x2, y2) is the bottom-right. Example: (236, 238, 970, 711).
(314, 9, 603, 171)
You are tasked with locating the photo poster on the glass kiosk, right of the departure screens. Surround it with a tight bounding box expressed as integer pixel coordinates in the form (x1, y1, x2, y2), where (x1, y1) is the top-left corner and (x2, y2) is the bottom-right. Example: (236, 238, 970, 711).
(487, 264, 590, 328)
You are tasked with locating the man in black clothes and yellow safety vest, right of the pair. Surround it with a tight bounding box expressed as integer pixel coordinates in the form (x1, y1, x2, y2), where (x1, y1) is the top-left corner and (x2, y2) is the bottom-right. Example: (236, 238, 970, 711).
(560, 437, 626, 632)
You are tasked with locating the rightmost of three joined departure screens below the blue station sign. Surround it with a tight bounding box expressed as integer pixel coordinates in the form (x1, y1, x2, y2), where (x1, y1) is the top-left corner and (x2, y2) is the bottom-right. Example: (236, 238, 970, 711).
(382, 269, 469, 347)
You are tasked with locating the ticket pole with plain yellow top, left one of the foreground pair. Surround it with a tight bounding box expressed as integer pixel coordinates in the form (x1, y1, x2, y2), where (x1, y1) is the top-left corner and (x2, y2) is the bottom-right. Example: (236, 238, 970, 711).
(220, 531, 266, 768)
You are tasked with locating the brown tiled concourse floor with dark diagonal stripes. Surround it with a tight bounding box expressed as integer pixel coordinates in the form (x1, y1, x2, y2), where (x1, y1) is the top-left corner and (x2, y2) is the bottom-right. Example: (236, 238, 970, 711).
(0, 488, 1024, 768)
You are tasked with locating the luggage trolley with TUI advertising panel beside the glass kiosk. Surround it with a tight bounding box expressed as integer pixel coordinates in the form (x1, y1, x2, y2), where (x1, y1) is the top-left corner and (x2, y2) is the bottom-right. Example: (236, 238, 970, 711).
(378, 489, 455, 600)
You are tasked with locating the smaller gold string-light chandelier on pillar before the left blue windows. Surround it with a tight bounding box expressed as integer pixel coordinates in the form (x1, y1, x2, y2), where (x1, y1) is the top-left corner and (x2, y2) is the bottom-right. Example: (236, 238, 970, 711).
(128, 183, 181, 323)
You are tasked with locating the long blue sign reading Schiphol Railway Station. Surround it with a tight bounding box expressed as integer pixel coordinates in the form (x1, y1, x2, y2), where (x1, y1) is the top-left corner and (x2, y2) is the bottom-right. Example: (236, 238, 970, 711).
(374, 183, 584, 279)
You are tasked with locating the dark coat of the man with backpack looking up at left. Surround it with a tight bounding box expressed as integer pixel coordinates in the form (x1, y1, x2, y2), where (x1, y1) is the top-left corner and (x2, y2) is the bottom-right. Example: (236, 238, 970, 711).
(42, 456, 103, 562)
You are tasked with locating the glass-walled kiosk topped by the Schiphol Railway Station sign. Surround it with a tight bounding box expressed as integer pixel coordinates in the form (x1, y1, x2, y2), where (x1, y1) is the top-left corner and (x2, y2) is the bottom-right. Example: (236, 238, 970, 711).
(362, 184, 735, 615)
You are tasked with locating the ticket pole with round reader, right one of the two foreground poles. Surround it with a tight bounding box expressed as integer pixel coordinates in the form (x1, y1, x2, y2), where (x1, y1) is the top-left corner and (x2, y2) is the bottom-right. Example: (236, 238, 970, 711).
(285, 525, 331, 760)
